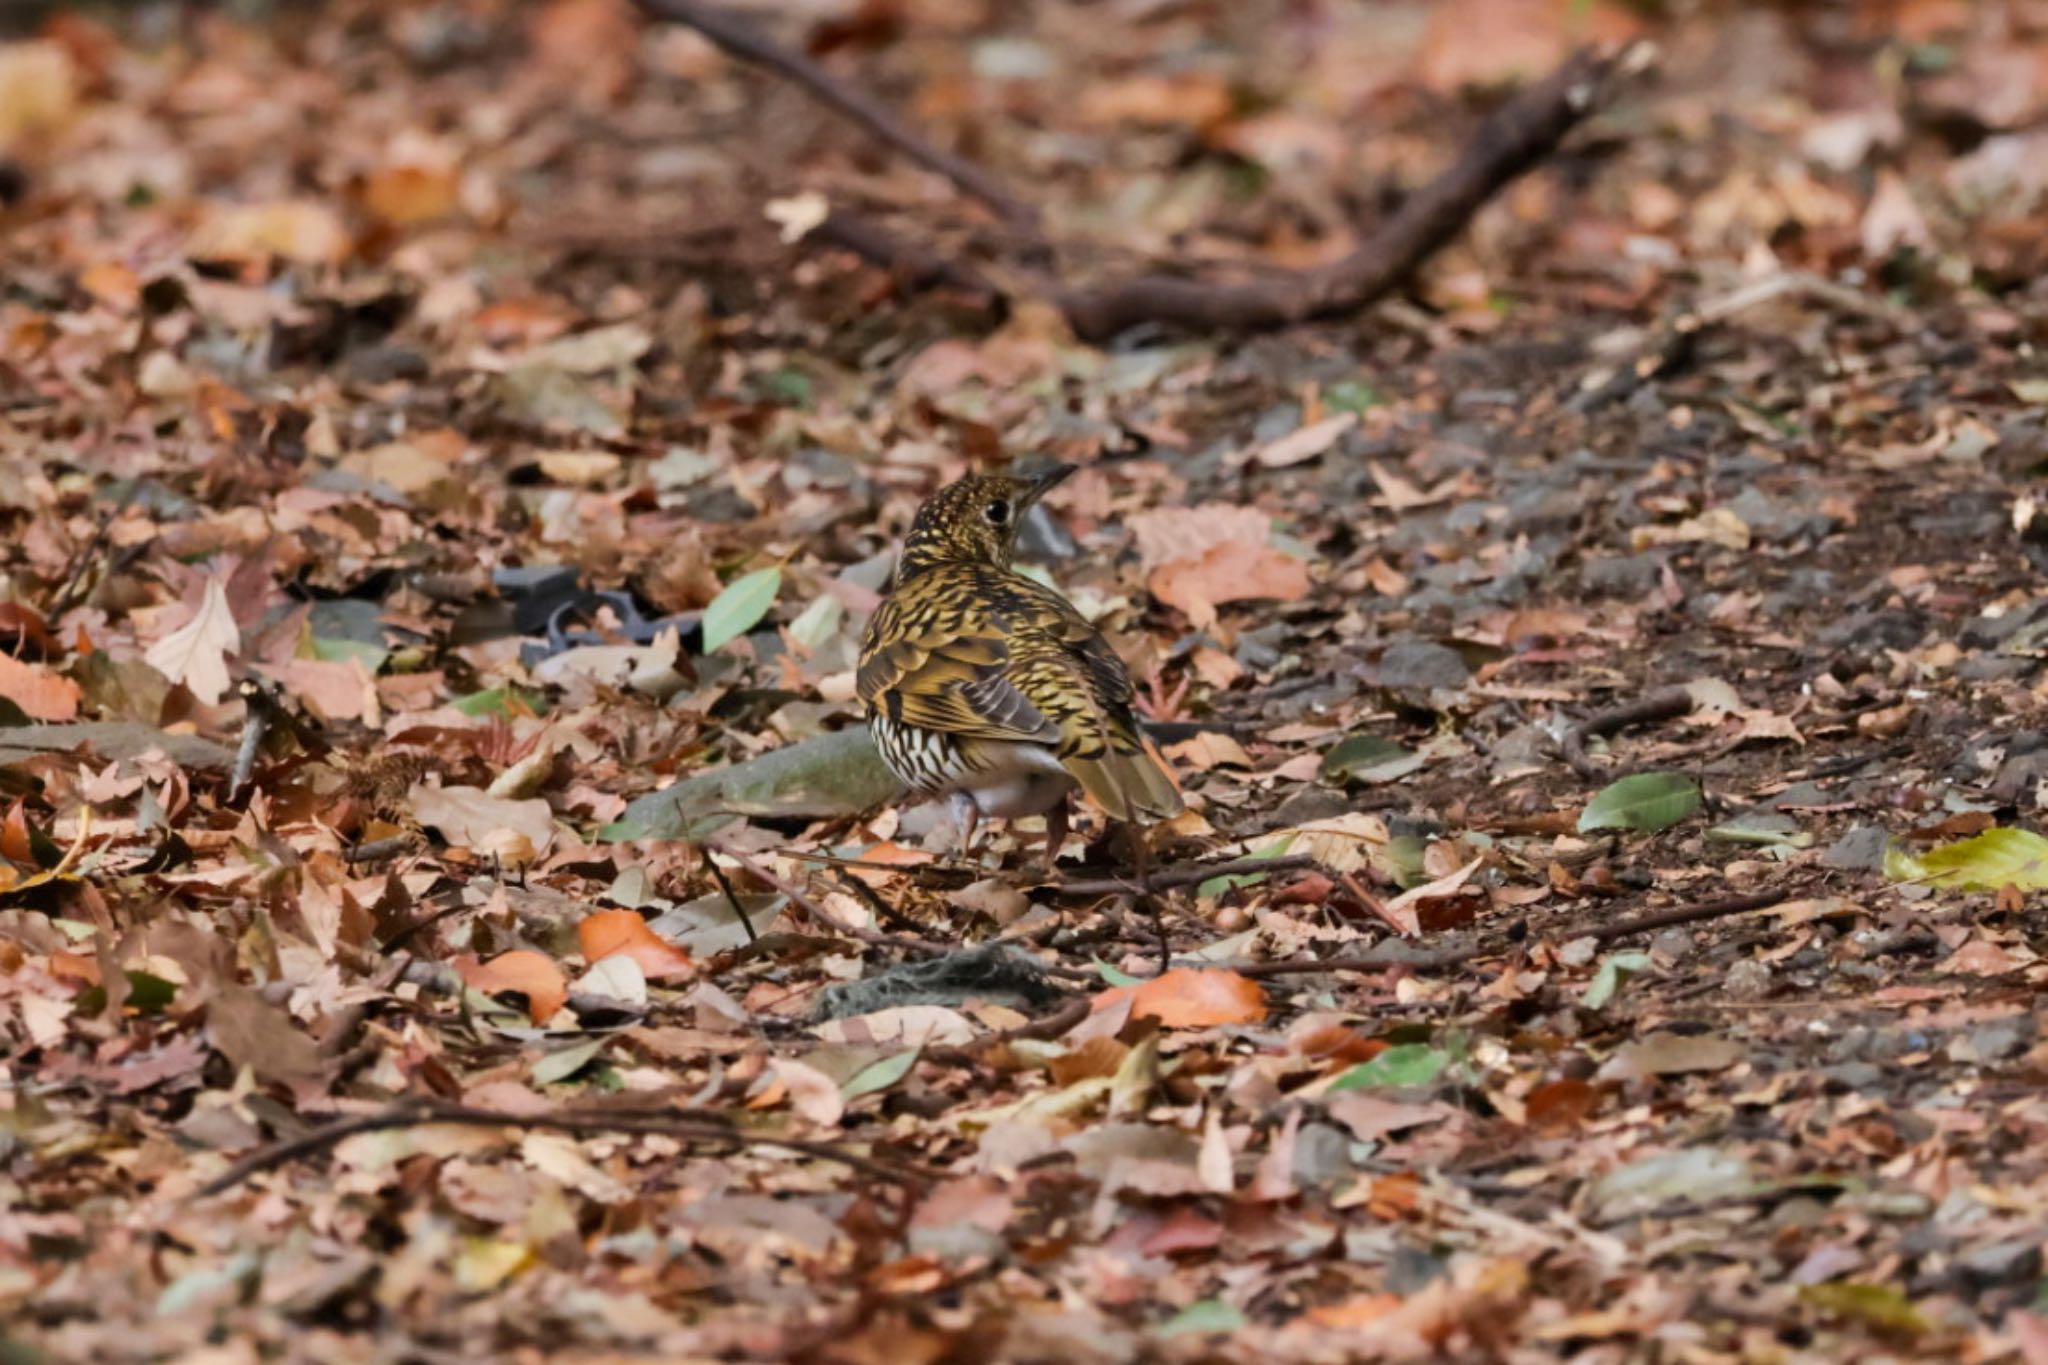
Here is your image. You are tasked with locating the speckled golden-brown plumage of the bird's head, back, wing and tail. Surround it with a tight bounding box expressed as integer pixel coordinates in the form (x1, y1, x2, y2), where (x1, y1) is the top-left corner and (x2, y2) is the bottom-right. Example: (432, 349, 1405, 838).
(858, 477, 1182, 821)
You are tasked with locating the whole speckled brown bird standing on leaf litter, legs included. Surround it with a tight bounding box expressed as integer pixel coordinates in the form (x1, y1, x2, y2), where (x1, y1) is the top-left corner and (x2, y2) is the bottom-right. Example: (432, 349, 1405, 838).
(856, 465, 1182, 872)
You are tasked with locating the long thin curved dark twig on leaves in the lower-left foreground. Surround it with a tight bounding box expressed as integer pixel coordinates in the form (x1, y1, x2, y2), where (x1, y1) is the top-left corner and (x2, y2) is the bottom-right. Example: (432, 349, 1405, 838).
(195, 1097, 932, 1199)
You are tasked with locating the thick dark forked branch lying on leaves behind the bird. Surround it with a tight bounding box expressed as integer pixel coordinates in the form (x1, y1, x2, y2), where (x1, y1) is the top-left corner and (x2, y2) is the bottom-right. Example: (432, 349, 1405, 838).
(635, 0, 1655, 340)
